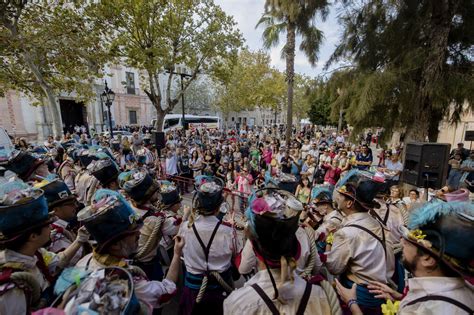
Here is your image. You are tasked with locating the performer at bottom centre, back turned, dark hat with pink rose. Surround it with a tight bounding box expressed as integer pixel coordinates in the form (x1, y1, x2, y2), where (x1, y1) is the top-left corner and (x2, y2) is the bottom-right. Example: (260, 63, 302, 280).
(224, 190, 341, 315)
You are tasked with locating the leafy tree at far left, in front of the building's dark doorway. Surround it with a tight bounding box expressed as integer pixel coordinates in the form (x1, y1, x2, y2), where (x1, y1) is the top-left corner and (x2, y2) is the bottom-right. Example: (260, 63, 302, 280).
(0, 0, 107, 136)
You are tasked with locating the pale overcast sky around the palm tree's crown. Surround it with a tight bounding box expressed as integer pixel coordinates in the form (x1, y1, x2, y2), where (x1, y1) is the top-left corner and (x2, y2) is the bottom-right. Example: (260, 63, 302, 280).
(215, 0, 341, 77)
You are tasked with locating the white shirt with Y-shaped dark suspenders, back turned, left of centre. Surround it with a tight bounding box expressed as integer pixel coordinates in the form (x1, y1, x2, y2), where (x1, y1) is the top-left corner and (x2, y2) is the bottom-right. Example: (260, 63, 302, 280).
(178, 216, 239, 274)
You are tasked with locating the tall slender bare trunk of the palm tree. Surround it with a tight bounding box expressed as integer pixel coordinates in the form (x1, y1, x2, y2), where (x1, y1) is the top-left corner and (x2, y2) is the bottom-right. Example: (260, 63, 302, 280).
(286, 22, 296, 147)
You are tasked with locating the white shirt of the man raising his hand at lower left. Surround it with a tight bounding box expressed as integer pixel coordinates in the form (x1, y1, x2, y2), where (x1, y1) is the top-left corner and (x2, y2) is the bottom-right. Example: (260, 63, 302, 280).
(76, 253, 176, 308)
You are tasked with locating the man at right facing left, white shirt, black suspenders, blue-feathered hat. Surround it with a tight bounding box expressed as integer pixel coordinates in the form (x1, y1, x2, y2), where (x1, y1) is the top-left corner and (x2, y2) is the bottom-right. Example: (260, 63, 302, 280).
(326, 170, 395, 314)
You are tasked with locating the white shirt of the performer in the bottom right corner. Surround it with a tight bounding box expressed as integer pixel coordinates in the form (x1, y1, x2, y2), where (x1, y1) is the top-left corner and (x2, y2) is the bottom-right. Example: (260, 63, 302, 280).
(397, 277, 474, 315)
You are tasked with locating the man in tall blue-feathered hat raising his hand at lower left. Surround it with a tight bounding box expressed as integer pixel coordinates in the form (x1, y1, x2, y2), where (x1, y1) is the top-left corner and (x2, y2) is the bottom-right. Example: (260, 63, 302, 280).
(76, 189, 184, 308)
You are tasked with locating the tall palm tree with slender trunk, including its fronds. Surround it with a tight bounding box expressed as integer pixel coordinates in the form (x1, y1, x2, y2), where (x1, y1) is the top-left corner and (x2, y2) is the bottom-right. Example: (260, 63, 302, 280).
(256, 0, 329, 145)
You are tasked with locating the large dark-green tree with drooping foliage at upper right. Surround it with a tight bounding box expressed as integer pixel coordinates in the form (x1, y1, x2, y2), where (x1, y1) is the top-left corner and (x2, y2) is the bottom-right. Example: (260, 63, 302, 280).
(330, 0, 474, 141)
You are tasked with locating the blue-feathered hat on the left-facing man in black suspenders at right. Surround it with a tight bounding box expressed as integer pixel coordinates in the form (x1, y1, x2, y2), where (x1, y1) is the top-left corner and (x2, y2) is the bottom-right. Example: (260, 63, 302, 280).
(334, 169, 385, 209)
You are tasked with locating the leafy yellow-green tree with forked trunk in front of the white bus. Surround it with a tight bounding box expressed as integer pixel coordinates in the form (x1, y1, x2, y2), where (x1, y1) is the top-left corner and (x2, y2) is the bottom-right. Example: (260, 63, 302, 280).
(90, 0, 242, 130)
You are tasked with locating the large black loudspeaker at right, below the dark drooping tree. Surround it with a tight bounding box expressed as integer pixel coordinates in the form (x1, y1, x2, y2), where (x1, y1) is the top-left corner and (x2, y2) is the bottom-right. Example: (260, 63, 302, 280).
(402, 142, 451, 189)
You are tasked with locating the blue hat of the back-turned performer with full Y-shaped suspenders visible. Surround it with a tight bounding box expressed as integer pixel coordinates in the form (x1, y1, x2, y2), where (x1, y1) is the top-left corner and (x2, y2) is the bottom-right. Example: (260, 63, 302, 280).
(193, 175, 224, 212)
